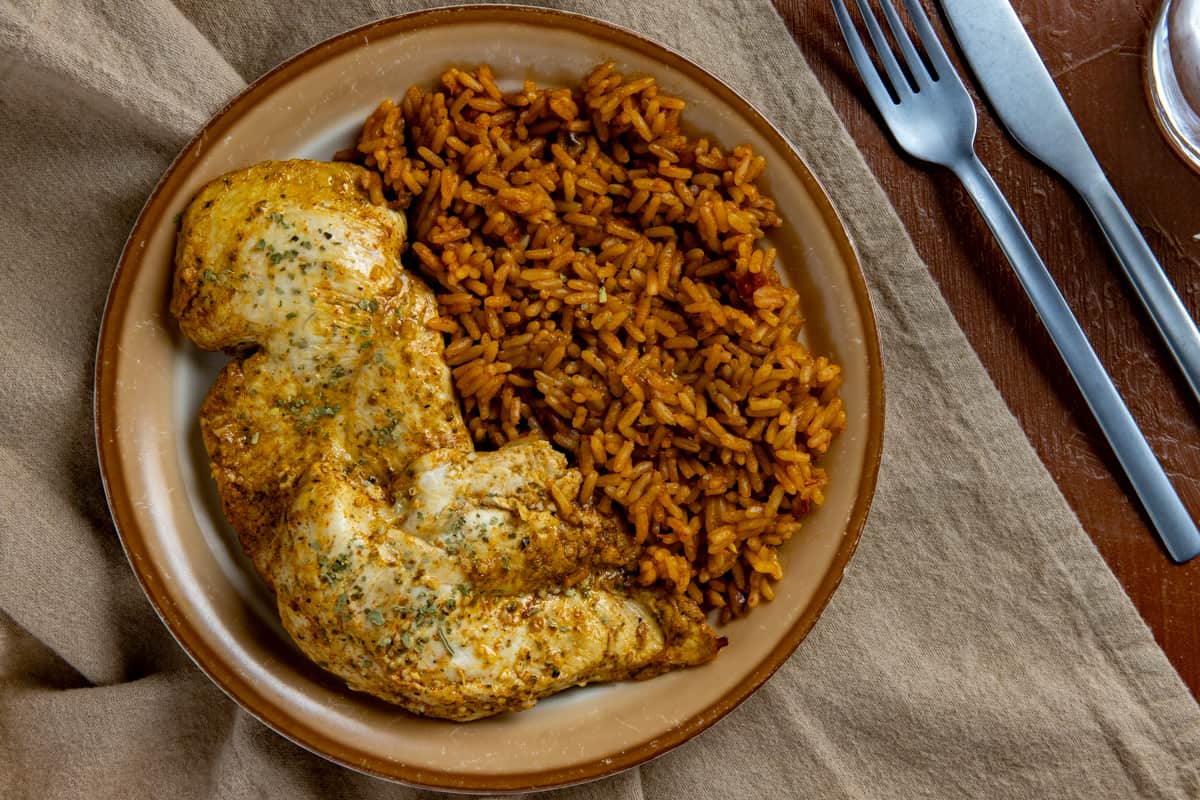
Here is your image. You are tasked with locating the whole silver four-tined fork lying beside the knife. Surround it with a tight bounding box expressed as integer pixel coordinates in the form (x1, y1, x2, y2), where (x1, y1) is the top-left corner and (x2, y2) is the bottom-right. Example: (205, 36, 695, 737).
(830, 0, 1200, 563)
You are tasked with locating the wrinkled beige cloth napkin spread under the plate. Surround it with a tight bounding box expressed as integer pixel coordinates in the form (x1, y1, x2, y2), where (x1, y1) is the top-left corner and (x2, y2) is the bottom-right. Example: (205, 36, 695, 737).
(0, 0, 1200, 800)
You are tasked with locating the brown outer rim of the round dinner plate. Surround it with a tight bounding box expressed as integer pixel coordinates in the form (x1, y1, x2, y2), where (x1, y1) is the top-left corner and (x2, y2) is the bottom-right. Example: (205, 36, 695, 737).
(92, 4, 884, 794)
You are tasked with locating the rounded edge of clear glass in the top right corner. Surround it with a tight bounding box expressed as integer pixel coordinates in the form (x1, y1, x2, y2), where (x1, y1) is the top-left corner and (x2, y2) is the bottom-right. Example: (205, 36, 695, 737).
(1146, 0, 1200, 170)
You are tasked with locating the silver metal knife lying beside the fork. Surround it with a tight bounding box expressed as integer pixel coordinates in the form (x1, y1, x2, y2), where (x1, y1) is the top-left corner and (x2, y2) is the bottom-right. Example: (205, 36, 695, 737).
(940, 0, 1200, 412)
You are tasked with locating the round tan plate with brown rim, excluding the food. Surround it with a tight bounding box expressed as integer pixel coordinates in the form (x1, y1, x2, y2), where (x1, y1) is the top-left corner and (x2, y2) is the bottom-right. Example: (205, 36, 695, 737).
(96, 6, 883, 792)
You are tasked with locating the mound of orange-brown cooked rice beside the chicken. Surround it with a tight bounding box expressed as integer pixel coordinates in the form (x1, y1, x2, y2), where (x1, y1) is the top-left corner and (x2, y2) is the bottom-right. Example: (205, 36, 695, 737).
(340, 64, 846, 620)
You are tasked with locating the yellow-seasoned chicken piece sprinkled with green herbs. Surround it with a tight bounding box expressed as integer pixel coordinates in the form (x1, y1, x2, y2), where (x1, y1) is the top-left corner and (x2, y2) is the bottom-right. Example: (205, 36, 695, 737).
(170, 161, 721, 720)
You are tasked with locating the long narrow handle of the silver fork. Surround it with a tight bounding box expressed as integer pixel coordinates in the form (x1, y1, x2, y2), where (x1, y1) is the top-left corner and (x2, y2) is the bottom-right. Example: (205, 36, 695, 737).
(948, 152, 1200, 563)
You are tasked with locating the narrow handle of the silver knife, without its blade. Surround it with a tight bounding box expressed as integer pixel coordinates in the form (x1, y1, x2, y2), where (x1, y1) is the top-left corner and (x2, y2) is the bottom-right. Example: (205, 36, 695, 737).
(1080, 178, 1200, 410)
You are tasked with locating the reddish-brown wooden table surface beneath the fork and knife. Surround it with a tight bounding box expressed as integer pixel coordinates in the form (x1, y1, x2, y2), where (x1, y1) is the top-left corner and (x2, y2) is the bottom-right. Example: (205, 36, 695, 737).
(775, 0, 1200, 694)
